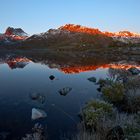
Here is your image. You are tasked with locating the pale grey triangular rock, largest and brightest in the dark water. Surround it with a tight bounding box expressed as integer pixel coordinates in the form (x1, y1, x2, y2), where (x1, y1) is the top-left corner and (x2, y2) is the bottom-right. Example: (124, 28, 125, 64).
(31, 108, 47, 120)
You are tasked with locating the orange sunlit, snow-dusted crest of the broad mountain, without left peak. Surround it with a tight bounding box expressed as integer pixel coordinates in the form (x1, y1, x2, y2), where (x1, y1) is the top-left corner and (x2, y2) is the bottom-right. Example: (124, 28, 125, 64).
(29, 24, 140, 43)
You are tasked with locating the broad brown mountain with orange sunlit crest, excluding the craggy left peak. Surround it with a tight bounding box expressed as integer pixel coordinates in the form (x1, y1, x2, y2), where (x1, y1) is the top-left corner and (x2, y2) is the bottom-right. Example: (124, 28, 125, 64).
(26, 24, 140, 47)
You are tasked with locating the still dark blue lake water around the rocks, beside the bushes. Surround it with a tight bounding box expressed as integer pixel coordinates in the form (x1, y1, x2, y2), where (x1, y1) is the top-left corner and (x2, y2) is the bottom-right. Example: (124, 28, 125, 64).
(0, 55, 139, 140)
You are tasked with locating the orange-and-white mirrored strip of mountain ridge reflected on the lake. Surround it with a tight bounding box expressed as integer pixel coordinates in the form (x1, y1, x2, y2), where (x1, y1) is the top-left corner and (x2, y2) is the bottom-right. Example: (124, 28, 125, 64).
(1, 56, 140, 74)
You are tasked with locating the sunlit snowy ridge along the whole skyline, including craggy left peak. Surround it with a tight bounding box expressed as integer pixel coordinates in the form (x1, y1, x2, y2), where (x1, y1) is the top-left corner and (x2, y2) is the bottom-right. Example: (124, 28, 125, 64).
(0, 24, 140, 41)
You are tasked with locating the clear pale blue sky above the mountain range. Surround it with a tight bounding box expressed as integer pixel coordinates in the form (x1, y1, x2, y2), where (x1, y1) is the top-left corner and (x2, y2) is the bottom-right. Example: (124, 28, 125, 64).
(0, 0, 140, 34)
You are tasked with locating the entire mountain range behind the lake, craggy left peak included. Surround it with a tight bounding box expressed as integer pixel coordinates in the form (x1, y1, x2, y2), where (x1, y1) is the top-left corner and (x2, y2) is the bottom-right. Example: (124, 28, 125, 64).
(0, 24, 140, 49)
